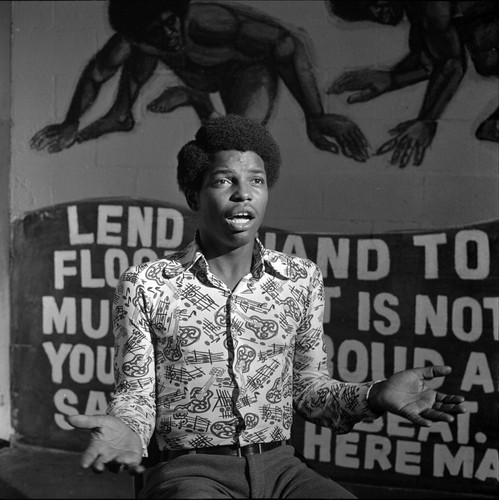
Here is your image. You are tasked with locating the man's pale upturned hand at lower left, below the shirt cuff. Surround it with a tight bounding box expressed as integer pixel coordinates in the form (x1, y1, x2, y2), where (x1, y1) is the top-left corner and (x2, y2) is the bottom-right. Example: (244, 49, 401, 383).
(67, 415, 144, 474)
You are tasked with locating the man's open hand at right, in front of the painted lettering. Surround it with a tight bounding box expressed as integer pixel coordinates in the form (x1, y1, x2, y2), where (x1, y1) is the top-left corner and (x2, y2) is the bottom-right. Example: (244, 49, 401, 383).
(369, 366, 466, 427)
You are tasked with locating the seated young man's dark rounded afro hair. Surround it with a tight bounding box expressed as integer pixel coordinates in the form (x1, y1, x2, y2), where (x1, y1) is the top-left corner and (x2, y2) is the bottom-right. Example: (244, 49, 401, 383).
(177, 115, 281, 193)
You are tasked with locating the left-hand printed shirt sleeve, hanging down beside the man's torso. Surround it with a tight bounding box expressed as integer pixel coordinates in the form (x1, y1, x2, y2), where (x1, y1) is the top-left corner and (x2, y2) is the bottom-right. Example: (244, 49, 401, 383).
(106, 264, 156, 456)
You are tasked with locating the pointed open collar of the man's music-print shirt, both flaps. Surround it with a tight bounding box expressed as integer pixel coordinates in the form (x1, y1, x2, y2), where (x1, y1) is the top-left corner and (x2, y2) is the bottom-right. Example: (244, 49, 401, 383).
(163, 231, 291, 279)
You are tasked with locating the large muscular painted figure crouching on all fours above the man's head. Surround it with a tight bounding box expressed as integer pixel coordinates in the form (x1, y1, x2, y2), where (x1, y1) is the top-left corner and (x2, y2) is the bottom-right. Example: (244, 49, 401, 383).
(31, 0, 368, 161)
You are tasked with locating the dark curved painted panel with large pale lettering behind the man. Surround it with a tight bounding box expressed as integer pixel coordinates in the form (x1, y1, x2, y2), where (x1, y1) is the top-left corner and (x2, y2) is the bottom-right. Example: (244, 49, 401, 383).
(11, 198, 499, 494)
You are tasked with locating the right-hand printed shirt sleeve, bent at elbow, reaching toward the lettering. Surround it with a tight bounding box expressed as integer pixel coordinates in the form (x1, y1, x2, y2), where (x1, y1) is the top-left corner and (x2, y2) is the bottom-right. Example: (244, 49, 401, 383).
(293, 262, 379, 434)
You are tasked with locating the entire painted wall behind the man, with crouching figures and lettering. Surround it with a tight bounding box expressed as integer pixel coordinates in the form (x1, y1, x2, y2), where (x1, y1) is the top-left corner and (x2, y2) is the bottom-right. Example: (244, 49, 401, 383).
(11, 0, 499, 494)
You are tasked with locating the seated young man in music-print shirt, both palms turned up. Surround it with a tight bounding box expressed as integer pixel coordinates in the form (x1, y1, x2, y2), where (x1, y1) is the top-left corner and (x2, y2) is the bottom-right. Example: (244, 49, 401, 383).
(68, 115, 465, 498)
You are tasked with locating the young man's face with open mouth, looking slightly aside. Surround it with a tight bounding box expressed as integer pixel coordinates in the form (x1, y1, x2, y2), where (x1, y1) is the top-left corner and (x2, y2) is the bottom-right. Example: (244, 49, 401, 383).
(191, 151, 268, 258)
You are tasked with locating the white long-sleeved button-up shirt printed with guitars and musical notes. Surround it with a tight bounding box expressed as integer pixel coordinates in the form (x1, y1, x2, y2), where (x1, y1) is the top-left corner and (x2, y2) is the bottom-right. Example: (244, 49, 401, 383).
(107, 235, 374, 454)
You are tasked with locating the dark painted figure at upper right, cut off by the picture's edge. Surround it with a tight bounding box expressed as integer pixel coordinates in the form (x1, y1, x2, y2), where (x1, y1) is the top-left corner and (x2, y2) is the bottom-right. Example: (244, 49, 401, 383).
(327, 0, 499, 167)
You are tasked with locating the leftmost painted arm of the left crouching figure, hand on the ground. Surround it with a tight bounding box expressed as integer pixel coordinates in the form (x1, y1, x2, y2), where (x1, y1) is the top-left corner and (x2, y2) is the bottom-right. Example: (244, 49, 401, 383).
(30, 34, 131, 153)
